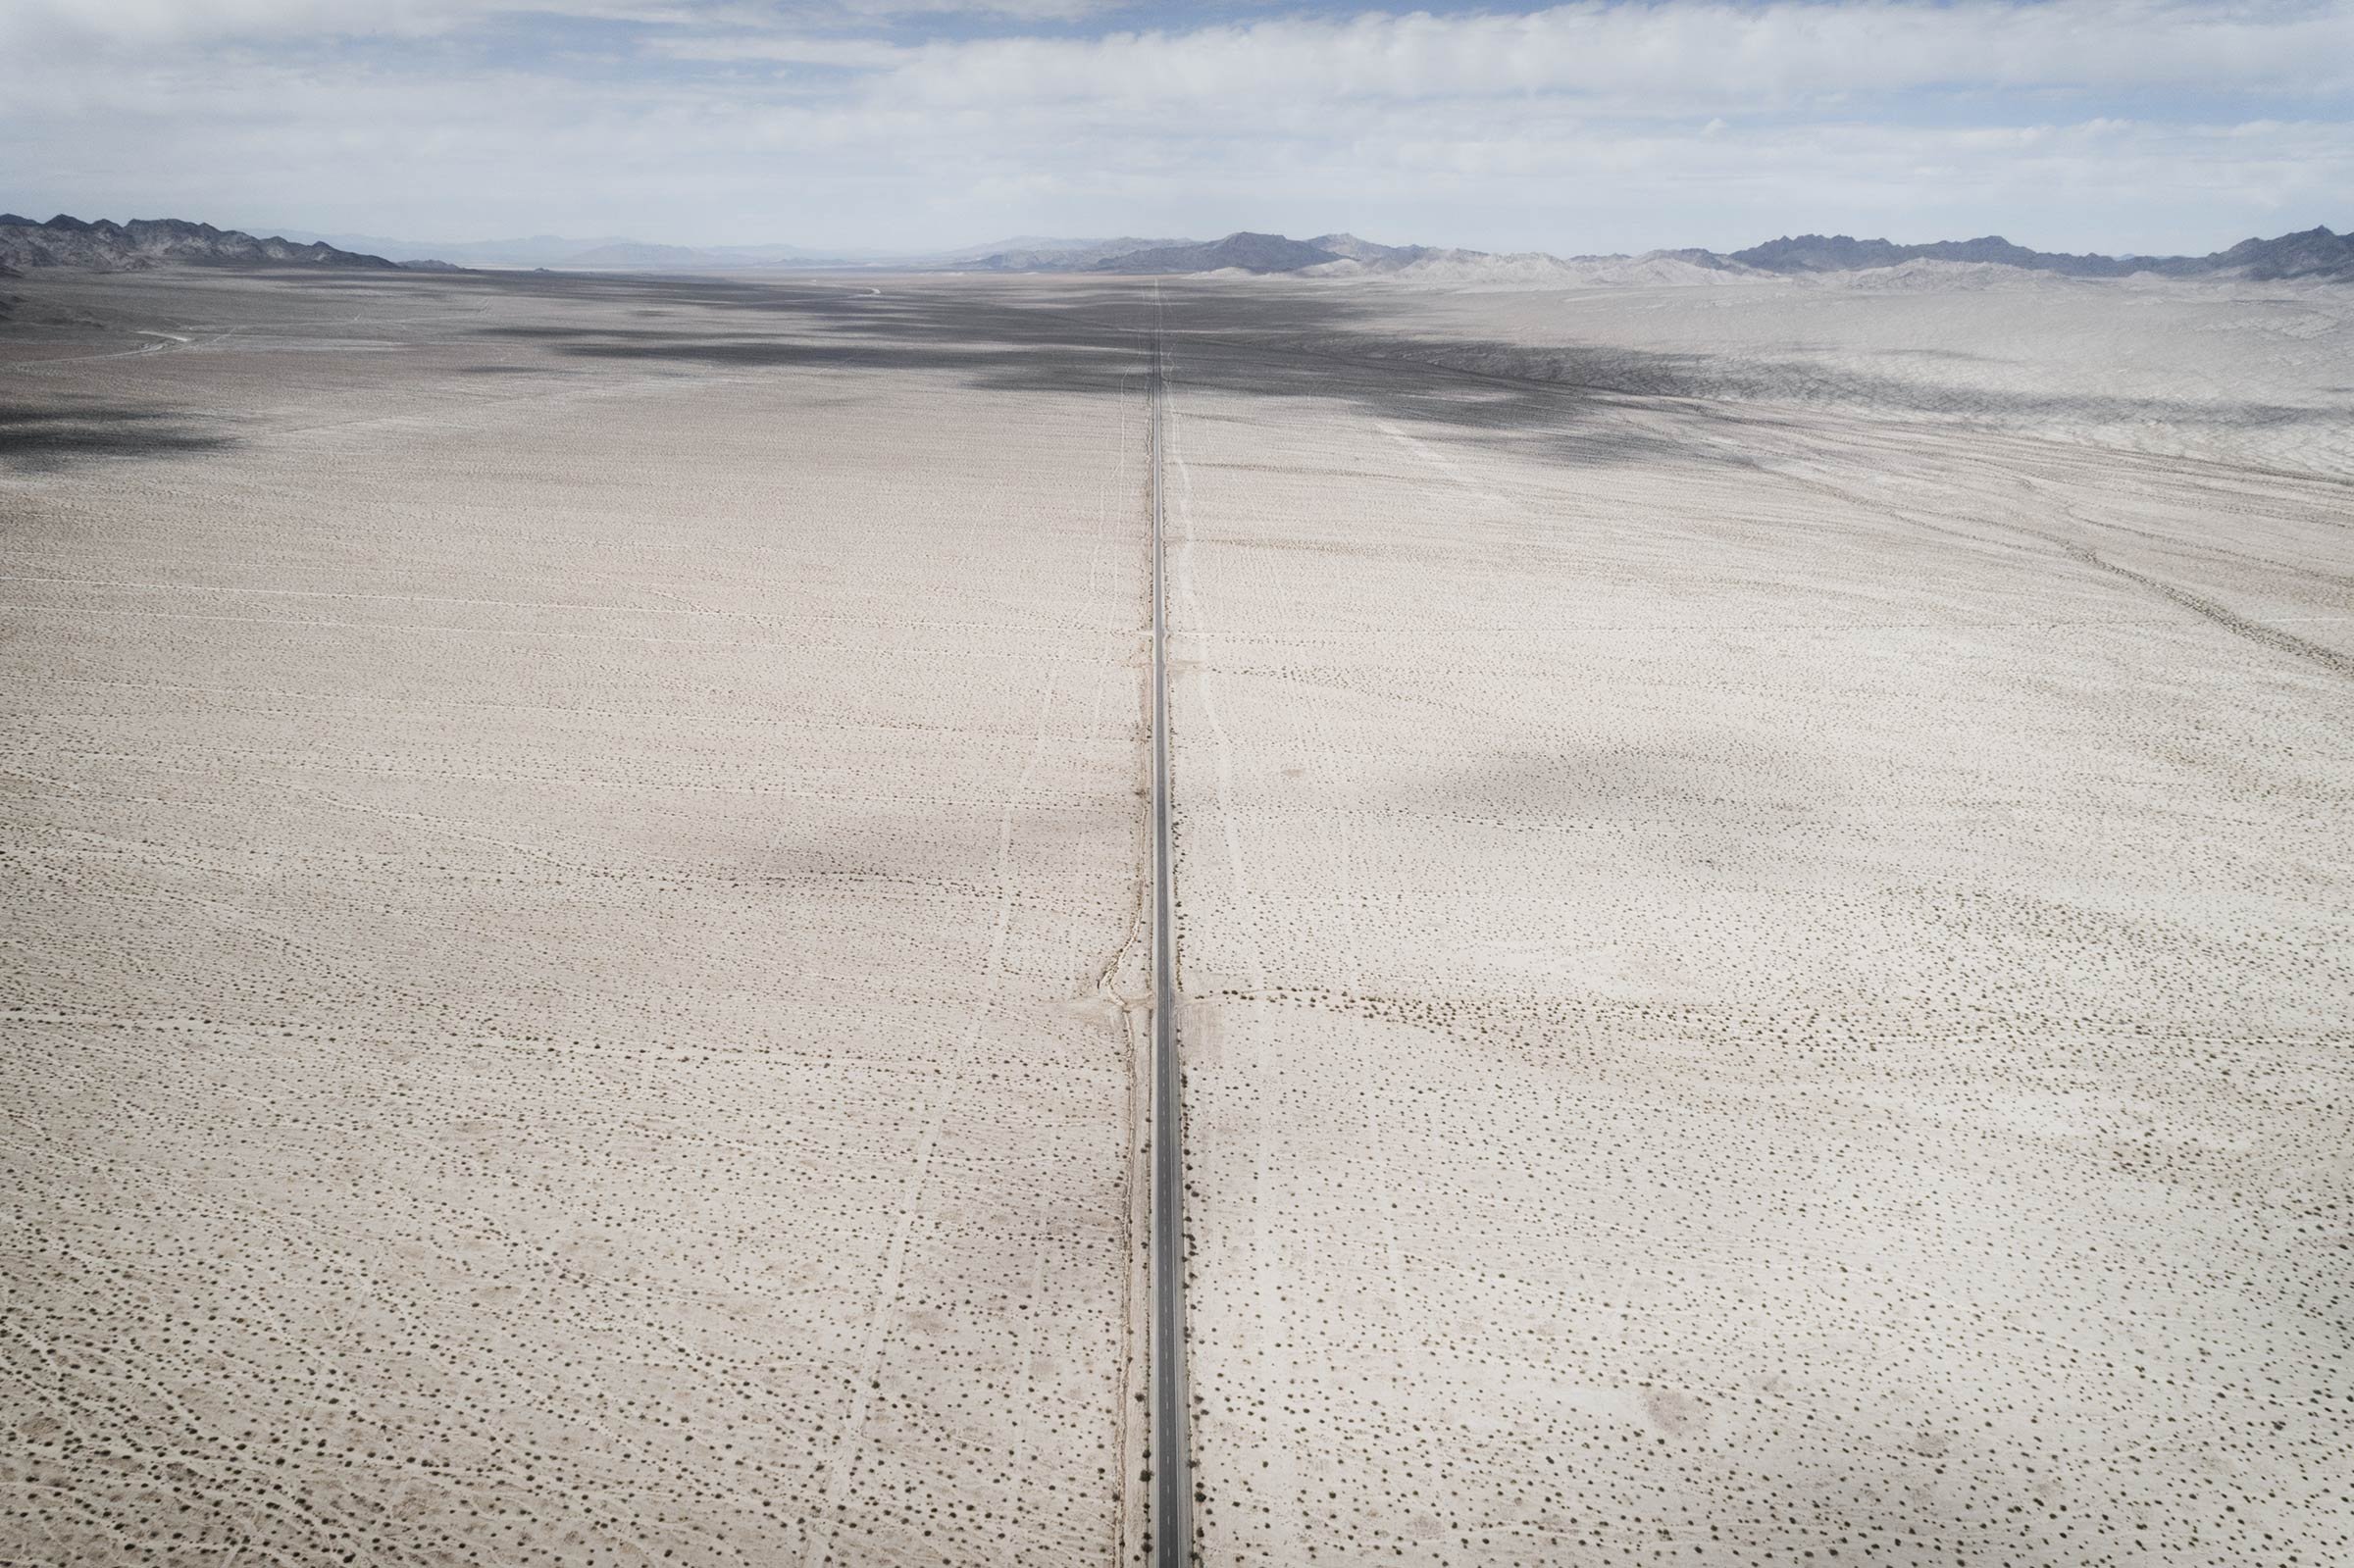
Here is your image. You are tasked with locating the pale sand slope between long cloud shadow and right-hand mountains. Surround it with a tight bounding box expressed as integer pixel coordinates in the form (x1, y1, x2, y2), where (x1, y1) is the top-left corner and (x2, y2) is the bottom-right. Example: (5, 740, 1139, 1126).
(1290, 262, 2354, 478)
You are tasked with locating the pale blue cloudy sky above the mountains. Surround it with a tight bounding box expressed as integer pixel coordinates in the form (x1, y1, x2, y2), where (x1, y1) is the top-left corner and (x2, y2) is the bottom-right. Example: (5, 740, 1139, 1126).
(0, 0, 2354, 254)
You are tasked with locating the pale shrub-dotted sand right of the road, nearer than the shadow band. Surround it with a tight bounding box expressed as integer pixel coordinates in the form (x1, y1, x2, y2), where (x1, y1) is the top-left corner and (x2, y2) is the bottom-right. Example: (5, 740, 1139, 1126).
(1170, 274, 2354, 1568)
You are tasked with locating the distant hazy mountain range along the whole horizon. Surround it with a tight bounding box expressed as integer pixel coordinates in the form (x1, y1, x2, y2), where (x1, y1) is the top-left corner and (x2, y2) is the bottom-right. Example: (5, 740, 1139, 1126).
(0, 214, 2354, 287)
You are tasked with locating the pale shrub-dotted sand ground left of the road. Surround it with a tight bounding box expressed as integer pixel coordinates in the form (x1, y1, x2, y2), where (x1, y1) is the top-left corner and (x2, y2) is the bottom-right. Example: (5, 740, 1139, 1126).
(0, 278, 1147, 1568)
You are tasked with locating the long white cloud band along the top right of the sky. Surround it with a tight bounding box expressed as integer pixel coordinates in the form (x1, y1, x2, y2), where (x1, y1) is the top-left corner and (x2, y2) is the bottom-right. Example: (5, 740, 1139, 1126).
(866, 0, 2354, 106)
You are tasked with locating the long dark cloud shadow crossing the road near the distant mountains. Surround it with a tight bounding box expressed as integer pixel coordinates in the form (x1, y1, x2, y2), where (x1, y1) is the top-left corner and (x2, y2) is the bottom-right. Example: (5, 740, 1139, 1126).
(395, 276, 2332, 451)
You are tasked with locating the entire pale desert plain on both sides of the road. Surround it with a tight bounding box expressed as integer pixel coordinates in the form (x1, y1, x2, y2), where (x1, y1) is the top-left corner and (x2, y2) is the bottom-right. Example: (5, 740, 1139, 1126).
(0, 266, 2354, 1568)
